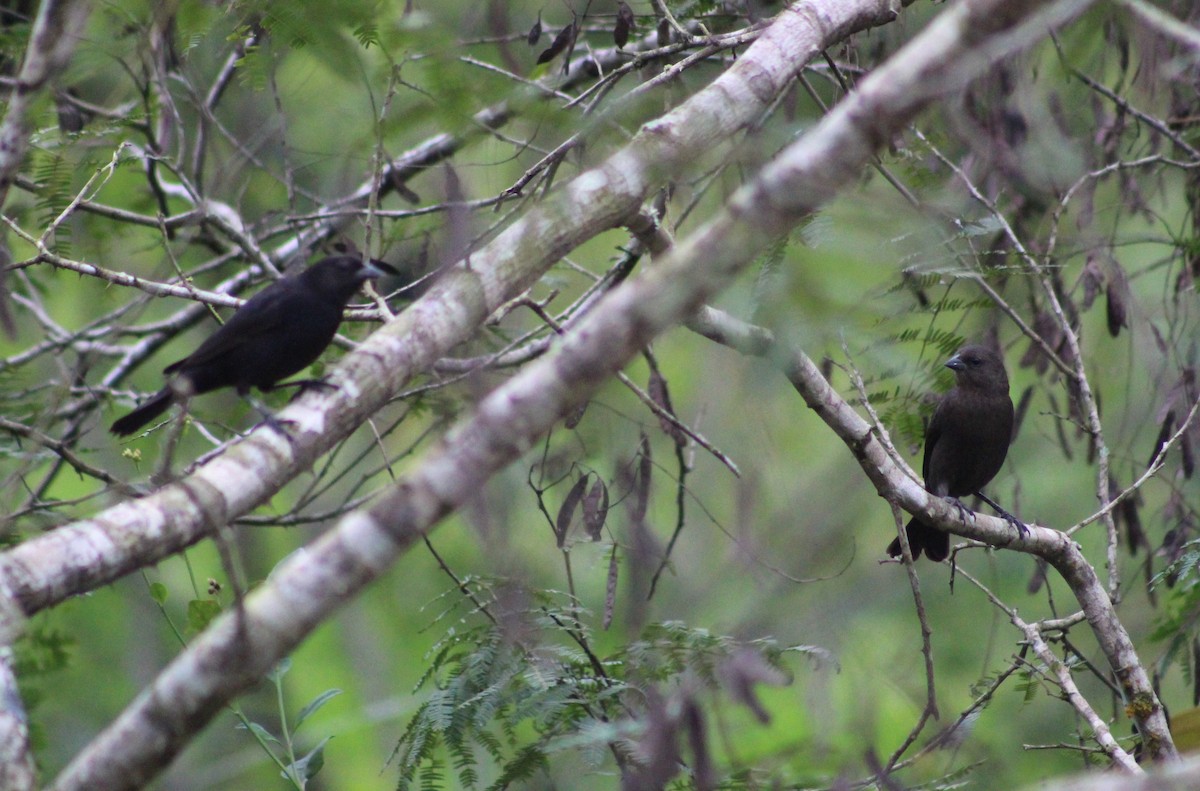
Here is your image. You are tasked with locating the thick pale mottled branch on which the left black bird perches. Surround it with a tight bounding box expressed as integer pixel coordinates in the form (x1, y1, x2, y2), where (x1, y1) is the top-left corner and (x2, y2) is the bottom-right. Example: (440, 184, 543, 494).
(0, 0, 895, 613)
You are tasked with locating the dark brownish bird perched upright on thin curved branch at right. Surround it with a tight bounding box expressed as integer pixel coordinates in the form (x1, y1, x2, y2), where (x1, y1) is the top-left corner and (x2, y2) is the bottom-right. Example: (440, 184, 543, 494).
(888, 346, 1028, 562)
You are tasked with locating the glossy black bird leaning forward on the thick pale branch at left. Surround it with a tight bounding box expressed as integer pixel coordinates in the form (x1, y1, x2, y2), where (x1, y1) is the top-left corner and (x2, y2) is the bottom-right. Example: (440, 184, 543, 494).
(110, 256, 395, 436)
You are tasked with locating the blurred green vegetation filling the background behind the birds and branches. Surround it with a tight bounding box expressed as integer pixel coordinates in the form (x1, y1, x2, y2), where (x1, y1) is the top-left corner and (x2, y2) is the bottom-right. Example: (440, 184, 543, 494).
(0, 0, 1200, 790)
